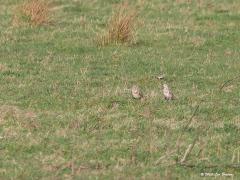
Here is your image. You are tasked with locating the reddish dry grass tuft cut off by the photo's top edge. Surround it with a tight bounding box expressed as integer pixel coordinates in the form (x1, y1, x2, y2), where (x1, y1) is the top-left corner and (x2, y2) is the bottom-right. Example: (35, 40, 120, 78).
(13, 0, 50, 26)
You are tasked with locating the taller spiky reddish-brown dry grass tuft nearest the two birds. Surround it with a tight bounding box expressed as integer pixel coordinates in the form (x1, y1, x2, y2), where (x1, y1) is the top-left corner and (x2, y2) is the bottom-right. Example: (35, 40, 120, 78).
(97, 6, 137, 46)
